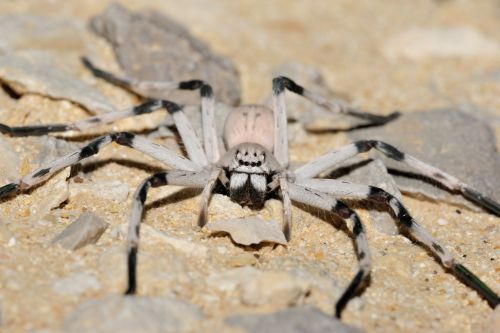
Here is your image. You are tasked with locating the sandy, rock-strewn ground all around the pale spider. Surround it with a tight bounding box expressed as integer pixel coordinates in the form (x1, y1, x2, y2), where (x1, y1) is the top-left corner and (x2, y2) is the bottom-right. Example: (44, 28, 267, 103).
(0, 0, 500, 333)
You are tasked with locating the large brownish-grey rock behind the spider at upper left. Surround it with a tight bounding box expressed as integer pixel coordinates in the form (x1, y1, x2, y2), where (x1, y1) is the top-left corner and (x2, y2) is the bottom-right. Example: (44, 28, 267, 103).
(91, 4, 240, 105)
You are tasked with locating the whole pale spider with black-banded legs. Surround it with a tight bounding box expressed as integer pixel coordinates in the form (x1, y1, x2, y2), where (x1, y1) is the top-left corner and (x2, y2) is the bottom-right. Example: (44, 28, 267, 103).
(0, 60, 500, 317)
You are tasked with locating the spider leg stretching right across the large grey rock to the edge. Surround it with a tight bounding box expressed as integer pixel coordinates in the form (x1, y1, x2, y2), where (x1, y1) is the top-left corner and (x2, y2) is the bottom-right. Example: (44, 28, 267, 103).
(295, 140, 500, 216)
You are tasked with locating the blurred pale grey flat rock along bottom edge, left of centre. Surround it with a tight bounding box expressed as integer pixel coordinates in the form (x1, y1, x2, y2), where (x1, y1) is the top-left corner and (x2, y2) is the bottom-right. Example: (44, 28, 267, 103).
(63, 295, 203, 333)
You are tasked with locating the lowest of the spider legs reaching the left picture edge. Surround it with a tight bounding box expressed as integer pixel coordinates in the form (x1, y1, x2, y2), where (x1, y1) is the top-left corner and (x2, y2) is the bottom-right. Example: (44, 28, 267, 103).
(0, 132, 201, 198)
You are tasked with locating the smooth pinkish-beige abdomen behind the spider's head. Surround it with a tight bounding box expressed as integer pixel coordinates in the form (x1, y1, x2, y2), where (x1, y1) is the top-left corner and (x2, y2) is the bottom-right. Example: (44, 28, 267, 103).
(224, 105, 274, 151)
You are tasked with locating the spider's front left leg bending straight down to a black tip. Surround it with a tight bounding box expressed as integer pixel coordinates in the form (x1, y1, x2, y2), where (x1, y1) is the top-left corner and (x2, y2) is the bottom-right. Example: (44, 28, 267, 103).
(125, 170, 209, 295)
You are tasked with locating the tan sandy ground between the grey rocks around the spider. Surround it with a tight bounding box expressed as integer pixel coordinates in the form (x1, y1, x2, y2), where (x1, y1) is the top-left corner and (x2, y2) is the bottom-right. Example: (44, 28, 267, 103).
(0, 0, 500, 332)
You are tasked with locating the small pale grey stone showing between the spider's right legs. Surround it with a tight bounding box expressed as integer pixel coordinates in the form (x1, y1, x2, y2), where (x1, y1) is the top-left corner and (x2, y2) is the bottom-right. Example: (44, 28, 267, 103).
(335, 158, 403, 235)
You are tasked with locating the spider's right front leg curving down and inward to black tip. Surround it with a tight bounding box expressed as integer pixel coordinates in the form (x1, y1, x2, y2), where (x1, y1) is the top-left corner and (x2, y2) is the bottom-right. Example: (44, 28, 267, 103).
(288, 183, 372, 318)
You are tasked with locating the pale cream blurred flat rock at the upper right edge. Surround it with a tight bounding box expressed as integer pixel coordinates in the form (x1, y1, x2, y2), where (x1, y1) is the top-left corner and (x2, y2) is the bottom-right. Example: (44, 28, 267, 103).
(383, 26, 500, 60)
